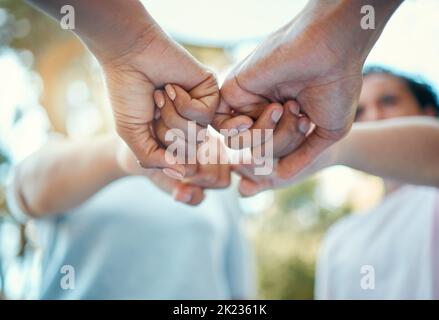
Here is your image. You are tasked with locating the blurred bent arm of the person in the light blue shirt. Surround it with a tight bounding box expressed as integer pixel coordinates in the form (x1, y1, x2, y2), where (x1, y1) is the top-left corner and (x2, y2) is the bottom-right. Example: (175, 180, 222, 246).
(11, 135, 210, 217)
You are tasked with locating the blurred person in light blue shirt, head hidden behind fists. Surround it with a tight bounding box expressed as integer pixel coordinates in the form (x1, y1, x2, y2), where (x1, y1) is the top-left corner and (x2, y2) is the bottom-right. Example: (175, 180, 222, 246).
(1, 87, 253, 299)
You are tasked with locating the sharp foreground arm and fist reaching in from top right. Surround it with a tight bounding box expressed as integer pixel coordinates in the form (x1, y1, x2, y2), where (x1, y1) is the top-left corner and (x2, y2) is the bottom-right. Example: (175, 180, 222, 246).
(220, 0, 402, 179)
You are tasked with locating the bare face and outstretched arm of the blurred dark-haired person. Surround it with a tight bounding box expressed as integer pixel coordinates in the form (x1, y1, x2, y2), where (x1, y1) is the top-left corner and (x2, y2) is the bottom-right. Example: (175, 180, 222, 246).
(235, 74, 439, 196)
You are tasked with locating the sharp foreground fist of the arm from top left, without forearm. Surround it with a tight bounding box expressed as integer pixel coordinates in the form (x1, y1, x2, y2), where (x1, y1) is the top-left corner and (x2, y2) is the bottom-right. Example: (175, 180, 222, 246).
(102, 23, 225, 179)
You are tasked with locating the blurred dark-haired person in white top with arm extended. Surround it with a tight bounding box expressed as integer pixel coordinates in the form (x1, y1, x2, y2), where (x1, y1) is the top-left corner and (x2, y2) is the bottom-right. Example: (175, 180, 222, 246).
(236, 67, 439, 299)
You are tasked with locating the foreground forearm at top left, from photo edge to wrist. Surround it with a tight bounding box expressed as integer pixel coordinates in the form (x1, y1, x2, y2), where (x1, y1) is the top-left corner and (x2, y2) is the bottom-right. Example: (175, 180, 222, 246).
(28, 0, 158, 60)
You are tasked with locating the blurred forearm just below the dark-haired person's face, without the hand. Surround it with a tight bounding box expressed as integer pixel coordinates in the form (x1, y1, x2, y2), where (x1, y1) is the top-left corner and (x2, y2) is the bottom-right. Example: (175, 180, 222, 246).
(334, 117, 439, 187)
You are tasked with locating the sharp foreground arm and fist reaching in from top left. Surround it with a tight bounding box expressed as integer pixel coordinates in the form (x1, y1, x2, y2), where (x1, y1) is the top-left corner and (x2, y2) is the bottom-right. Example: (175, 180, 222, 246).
(30, 0, 229, 178)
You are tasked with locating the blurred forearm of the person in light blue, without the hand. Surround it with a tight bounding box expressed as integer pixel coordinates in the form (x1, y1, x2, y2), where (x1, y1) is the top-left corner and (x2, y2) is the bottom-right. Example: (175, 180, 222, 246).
(13, 136, 124, 216)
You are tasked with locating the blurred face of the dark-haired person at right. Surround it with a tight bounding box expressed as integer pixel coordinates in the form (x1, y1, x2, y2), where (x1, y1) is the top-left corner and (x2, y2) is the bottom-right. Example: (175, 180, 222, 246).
(356, 73, 431, 121)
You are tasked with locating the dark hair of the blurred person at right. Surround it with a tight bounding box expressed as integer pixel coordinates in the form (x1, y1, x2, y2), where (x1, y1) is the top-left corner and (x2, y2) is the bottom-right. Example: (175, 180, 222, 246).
(363, 66, 439, 116)
